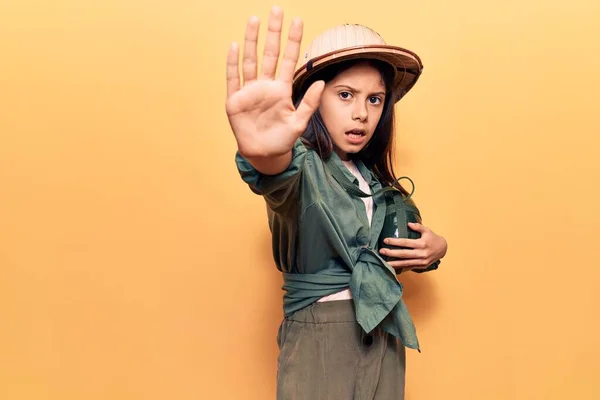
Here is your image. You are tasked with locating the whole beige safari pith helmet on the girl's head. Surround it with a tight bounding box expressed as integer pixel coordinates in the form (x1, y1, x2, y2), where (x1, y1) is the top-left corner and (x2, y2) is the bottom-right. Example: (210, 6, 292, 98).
(293, 24, 423, 102)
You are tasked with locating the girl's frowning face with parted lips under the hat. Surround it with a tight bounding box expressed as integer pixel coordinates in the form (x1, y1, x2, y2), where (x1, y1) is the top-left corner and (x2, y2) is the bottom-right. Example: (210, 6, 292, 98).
(319, 63, 385, 160)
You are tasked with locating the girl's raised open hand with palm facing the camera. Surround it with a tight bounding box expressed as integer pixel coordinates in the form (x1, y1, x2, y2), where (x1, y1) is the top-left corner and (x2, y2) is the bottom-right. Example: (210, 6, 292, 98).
(225, 7, 324, 160)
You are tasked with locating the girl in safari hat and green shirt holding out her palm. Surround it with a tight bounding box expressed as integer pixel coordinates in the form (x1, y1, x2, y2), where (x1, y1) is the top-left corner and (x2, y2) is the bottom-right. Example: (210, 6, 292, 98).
(226, 7, 447, 400)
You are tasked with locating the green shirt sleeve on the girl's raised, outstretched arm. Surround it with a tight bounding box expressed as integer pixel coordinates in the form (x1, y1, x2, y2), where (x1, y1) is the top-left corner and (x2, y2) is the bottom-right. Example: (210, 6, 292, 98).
(236, 139, 307, 212)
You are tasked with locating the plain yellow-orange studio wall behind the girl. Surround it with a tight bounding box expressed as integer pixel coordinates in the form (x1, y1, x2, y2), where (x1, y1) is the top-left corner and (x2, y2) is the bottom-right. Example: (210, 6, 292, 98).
(0, 0, 600, 400)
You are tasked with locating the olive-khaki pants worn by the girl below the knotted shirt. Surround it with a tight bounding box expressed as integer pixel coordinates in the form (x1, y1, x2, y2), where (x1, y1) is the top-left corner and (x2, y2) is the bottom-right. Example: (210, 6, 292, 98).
(277, 300, 406, 400)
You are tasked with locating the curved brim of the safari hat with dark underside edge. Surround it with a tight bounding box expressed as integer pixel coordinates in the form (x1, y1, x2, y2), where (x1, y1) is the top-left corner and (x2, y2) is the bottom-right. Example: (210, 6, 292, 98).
(293, 45, 423, 102)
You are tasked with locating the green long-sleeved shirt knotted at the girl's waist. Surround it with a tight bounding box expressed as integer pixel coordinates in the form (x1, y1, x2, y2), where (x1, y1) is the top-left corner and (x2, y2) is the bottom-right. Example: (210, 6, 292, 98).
(236, 139, 419, 349)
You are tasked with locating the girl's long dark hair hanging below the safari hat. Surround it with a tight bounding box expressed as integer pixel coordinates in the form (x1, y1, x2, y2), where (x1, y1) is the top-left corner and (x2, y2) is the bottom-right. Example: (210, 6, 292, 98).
(294, 59, 408, 195)
